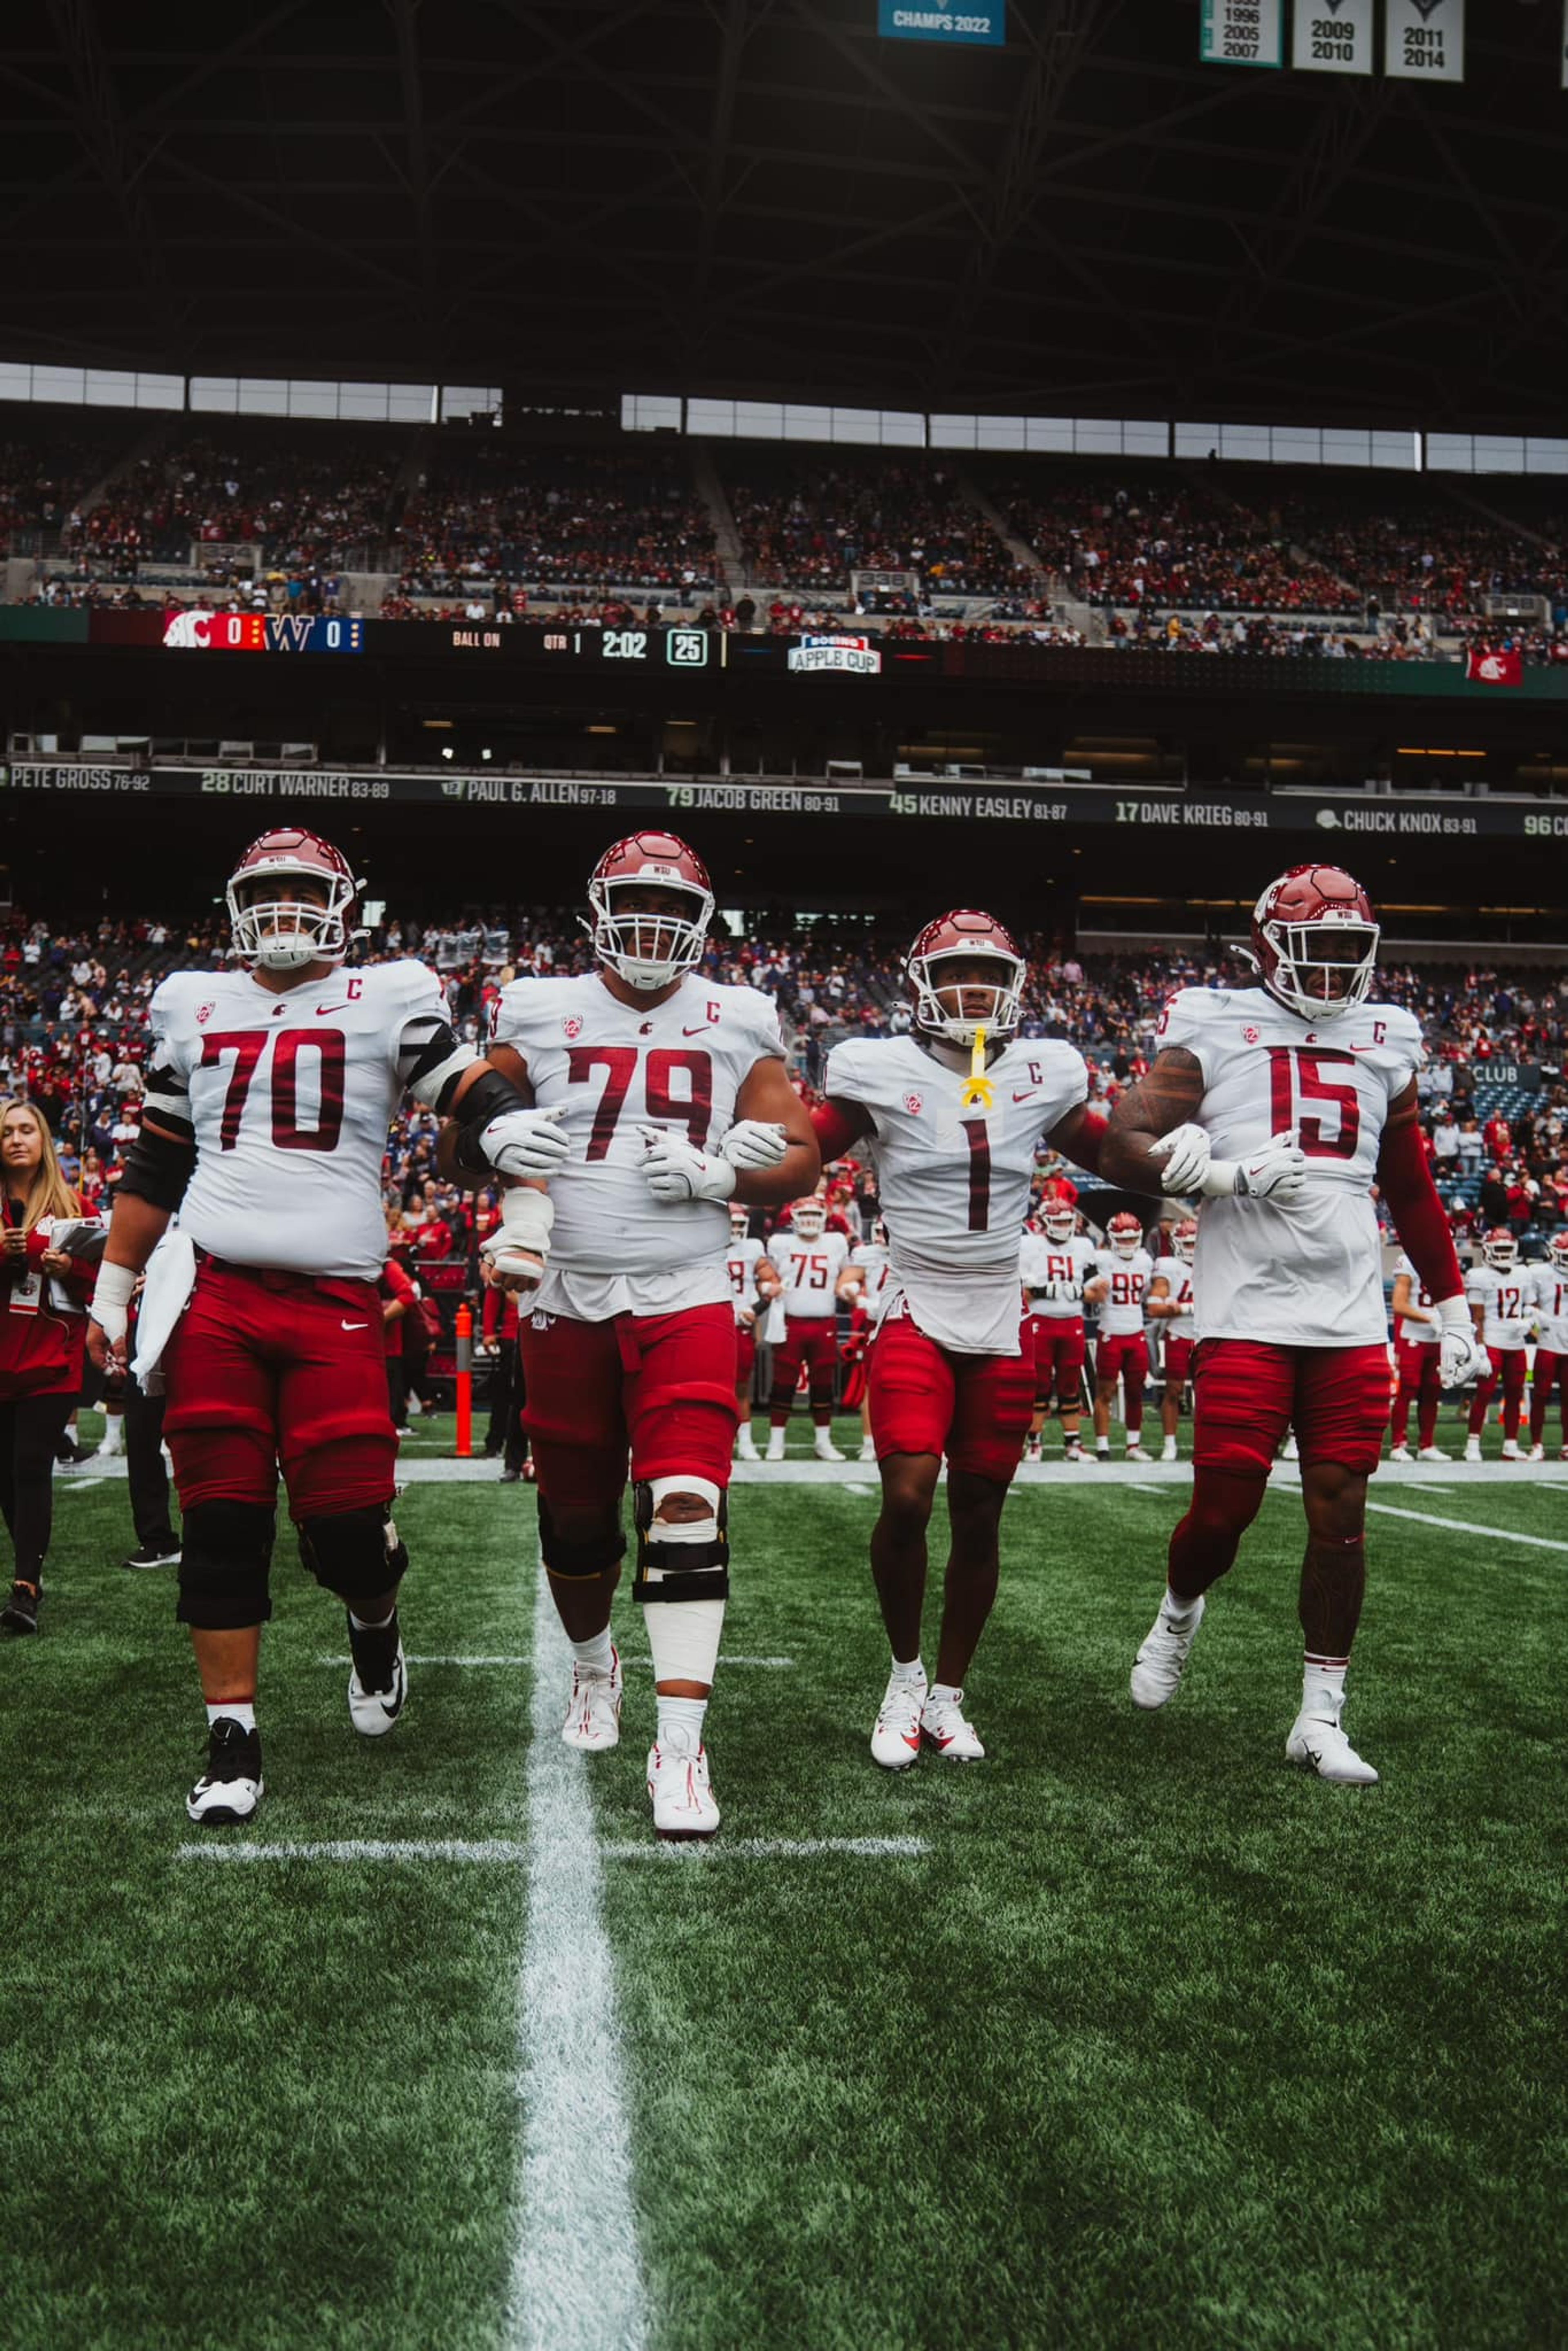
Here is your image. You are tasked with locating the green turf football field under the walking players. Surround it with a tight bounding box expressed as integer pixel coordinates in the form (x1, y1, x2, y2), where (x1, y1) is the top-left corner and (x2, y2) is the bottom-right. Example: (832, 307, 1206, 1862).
(0, 1415, 1568, 2351)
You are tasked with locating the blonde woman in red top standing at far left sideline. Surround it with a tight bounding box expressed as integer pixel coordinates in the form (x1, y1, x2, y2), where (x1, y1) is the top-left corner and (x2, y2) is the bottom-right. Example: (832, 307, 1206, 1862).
(0, 1100, 96, 1634)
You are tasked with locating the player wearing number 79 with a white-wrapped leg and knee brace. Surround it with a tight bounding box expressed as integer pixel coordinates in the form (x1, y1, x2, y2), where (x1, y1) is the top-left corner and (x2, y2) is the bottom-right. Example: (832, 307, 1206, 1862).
(472, 832, 820, 1836)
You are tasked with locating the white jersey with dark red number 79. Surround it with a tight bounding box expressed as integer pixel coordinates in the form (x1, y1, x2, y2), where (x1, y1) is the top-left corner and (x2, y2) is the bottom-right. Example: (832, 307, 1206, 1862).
(491, 971, 783, 1321)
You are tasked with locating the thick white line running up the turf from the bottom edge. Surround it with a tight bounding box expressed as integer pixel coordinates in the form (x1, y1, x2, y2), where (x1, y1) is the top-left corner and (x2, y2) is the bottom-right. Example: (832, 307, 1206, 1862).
(503, 1563, 653, 2351)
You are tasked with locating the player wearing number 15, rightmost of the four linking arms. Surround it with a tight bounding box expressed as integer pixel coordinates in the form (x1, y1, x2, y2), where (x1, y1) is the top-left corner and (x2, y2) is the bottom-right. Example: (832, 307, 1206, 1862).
(1102, 865, 1481, 1785)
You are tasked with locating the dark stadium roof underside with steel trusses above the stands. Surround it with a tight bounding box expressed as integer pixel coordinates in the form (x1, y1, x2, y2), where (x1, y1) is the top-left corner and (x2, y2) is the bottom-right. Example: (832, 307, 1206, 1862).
(0, 0, 1568, 432)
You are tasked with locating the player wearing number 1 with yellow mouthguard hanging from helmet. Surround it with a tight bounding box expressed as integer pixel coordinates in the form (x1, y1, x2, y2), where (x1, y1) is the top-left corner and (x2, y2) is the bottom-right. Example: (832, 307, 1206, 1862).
(811, 910, 1105, 1768)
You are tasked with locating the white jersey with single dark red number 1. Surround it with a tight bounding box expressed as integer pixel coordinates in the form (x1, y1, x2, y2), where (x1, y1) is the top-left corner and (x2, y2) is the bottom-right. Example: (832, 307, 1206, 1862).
(823, 1037, 1089, 1354)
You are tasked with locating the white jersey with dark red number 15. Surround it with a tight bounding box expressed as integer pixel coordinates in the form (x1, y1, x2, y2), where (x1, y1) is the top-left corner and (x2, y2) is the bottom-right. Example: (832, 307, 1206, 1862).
(1159, 987, 1422, 1347)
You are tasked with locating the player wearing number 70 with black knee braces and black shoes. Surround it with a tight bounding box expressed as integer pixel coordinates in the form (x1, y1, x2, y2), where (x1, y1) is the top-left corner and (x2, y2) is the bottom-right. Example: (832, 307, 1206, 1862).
(89, 825, 564, 1824)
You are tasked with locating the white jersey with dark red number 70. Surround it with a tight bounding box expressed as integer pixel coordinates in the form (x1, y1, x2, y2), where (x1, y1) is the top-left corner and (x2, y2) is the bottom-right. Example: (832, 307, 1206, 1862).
(146, 962, 456, 1281)
